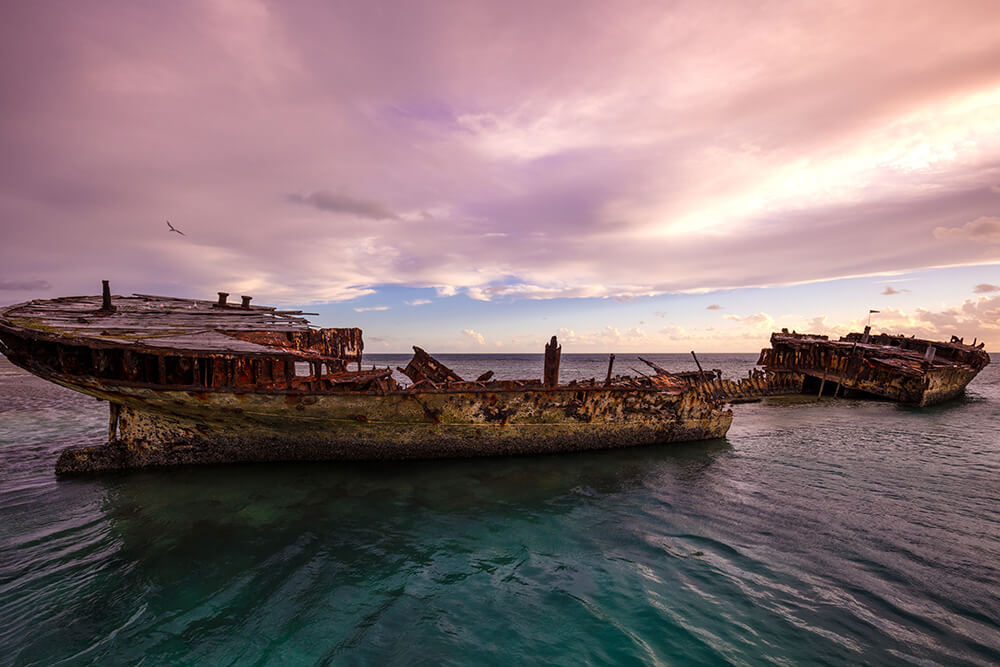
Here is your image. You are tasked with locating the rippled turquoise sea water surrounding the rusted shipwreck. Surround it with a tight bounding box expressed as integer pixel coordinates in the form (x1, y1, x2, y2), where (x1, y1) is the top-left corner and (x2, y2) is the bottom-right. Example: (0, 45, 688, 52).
(0, 355, 1000, 665)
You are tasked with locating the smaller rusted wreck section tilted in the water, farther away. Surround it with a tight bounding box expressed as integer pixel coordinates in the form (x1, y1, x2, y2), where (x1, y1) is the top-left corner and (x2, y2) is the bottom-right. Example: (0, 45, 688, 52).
(757, 327, 990, 407)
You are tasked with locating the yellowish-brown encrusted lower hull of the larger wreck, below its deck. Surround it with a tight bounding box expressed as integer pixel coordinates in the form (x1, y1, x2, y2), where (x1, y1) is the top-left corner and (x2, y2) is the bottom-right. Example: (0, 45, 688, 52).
(47, 376, 732, 473)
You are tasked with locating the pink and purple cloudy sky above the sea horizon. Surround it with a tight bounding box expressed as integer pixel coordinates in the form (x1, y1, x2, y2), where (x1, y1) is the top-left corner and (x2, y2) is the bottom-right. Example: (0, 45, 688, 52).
(0, 0, 1000, 352)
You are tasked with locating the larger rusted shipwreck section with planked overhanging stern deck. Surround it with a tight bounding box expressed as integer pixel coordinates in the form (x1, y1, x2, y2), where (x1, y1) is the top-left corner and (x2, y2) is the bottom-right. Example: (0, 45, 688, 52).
(0, 281, 732, 473)
